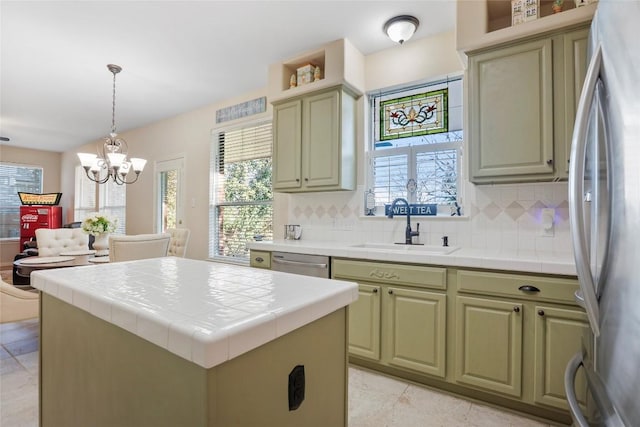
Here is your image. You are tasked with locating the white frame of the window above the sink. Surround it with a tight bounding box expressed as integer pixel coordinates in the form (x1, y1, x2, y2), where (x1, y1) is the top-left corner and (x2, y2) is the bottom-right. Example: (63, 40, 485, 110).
(362, 73, 465, 219)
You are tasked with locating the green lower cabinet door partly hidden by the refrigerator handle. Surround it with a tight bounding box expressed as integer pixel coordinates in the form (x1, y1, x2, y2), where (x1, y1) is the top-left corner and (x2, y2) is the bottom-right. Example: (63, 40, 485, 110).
(534, 305, 590, 413)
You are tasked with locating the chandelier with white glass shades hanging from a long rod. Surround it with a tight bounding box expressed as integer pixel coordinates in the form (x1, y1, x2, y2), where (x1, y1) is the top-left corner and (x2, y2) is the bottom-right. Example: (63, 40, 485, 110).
(78, 64, 147, 185)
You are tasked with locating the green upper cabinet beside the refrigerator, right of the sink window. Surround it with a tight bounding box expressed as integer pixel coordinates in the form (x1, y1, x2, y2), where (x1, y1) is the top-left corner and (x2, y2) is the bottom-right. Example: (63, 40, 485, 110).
(468, 24, 588, 183)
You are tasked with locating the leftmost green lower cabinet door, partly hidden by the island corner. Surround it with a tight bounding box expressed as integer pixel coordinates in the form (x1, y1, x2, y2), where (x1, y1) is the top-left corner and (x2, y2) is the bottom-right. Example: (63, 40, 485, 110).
(349, 284, 381, 361)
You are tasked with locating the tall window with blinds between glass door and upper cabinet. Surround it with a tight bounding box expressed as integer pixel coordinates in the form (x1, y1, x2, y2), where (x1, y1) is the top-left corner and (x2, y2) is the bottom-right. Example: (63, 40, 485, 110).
(209, 122, 273, 261)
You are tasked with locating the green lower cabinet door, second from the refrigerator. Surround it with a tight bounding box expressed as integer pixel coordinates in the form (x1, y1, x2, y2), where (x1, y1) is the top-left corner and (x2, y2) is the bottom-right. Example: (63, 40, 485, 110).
(455, 296, 523, 398)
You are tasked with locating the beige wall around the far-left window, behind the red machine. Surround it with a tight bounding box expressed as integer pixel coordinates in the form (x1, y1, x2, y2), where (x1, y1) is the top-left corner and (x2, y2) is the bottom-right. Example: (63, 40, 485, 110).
(0, 145, 62, 268)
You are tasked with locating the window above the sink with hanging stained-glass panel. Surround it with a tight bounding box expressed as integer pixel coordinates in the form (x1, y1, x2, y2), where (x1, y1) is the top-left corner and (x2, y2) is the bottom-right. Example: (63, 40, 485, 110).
(368, 77, 463, 215)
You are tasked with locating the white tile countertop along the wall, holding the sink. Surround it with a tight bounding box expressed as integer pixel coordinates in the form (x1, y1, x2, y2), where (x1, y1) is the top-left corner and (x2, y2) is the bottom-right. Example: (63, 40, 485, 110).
(249, 240, 576, 276)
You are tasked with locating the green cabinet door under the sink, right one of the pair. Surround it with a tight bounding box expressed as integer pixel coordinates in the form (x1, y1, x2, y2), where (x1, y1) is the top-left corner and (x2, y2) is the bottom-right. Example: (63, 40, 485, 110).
(383, 287, 447, 378)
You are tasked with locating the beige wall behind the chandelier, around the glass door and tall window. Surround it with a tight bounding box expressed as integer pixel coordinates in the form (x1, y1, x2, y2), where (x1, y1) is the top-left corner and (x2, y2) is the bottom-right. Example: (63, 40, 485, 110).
(57, 90, 272, 259)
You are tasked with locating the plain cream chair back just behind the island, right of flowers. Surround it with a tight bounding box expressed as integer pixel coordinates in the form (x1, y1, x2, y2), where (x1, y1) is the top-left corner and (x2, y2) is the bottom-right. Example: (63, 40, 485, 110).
(109, 233, 171, 262)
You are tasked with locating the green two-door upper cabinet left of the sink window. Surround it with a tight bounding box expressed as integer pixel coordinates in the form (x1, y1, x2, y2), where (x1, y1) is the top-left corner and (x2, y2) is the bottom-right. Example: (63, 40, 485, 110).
(273, 87, 356, 192)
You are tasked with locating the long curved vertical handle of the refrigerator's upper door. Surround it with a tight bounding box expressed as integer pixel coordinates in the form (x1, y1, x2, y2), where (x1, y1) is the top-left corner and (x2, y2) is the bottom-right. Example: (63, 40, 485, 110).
(569, 45, 602, 337)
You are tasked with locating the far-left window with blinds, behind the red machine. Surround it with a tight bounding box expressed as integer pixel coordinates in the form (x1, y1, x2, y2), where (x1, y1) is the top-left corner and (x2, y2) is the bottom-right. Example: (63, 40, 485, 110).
(0, 163, 42, 239)
